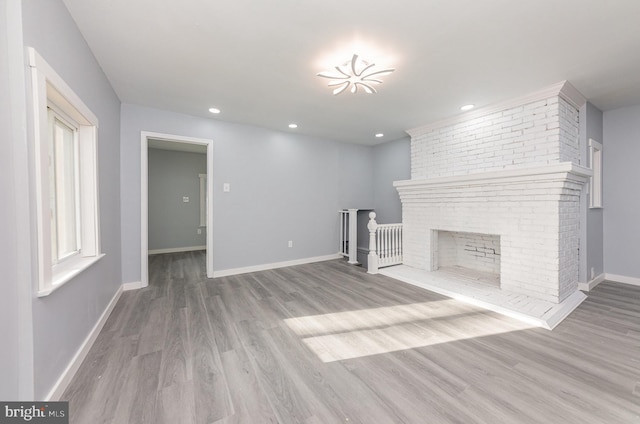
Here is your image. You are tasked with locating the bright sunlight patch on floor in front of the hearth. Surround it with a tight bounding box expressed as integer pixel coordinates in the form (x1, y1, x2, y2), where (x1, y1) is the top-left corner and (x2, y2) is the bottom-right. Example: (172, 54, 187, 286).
(285, 300, 535, 362)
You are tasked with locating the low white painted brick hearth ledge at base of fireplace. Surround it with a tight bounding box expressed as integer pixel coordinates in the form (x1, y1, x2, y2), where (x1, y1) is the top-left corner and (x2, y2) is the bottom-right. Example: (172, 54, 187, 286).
(380, 265, 587, 330)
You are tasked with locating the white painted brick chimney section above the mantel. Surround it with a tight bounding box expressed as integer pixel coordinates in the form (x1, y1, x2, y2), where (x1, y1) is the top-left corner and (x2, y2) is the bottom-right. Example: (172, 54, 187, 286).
(411, 96, 579, 179)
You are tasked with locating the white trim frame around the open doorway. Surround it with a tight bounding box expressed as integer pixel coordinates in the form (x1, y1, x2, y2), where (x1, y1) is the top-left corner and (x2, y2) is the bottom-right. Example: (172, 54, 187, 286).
(140, 131, 213, 287)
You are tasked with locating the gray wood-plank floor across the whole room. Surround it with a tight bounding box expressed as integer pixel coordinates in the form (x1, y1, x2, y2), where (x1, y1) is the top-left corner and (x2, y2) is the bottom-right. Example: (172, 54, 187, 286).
(63, 252, 640, 424)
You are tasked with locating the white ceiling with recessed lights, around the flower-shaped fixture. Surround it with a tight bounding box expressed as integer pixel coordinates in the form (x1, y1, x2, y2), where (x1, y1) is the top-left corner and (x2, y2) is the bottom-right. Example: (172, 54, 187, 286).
(64, 0, 640, 144)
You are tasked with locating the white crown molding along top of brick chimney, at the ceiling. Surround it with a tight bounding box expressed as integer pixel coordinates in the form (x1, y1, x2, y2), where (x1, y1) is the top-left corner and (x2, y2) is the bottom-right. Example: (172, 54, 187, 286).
(406, 81, 587, 137)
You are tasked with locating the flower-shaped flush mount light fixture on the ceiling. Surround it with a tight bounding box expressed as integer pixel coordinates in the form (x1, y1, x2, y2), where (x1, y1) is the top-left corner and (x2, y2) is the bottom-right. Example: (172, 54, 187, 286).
(316, 54, 395, 95)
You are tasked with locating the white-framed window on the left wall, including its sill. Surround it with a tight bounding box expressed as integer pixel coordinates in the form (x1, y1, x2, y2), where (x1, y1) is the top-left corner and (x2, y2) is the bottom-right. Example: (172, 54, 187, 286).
(29, 49, 104, 296)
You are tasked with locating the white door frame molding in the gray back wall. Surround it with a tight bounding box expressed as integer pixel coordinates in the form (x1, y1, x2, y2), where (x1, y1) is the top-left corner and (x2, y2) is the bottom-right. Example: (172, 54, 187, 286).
(140, 131, 213, 287)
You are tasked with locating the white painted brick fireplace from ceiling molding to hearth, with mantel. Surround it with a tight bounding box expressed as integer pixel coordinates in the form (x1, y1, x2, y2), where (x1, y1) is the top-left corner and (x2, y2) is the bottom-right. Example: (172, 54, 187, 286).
(395, 82, 590, 310)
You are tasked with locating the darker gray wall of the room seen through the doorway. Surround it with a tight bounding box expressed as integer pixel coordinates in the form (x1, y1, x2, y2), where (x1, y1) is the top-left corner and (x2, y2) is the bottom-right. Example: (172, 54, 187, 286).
(148, 149, 207, 250)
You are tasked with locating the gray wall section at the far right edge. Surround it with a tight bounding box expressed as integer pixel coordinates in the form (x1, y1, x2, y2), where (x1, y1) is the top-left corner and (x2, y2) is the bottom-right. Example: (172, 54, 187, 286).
(602, 105, 640, 278)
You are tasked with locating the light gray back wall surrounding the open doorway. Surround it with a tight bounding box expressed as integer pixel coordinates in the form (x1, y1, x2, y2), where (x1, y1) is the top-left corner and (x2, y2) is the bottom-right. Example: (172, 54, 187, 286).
(121, 104, 373, 282)
